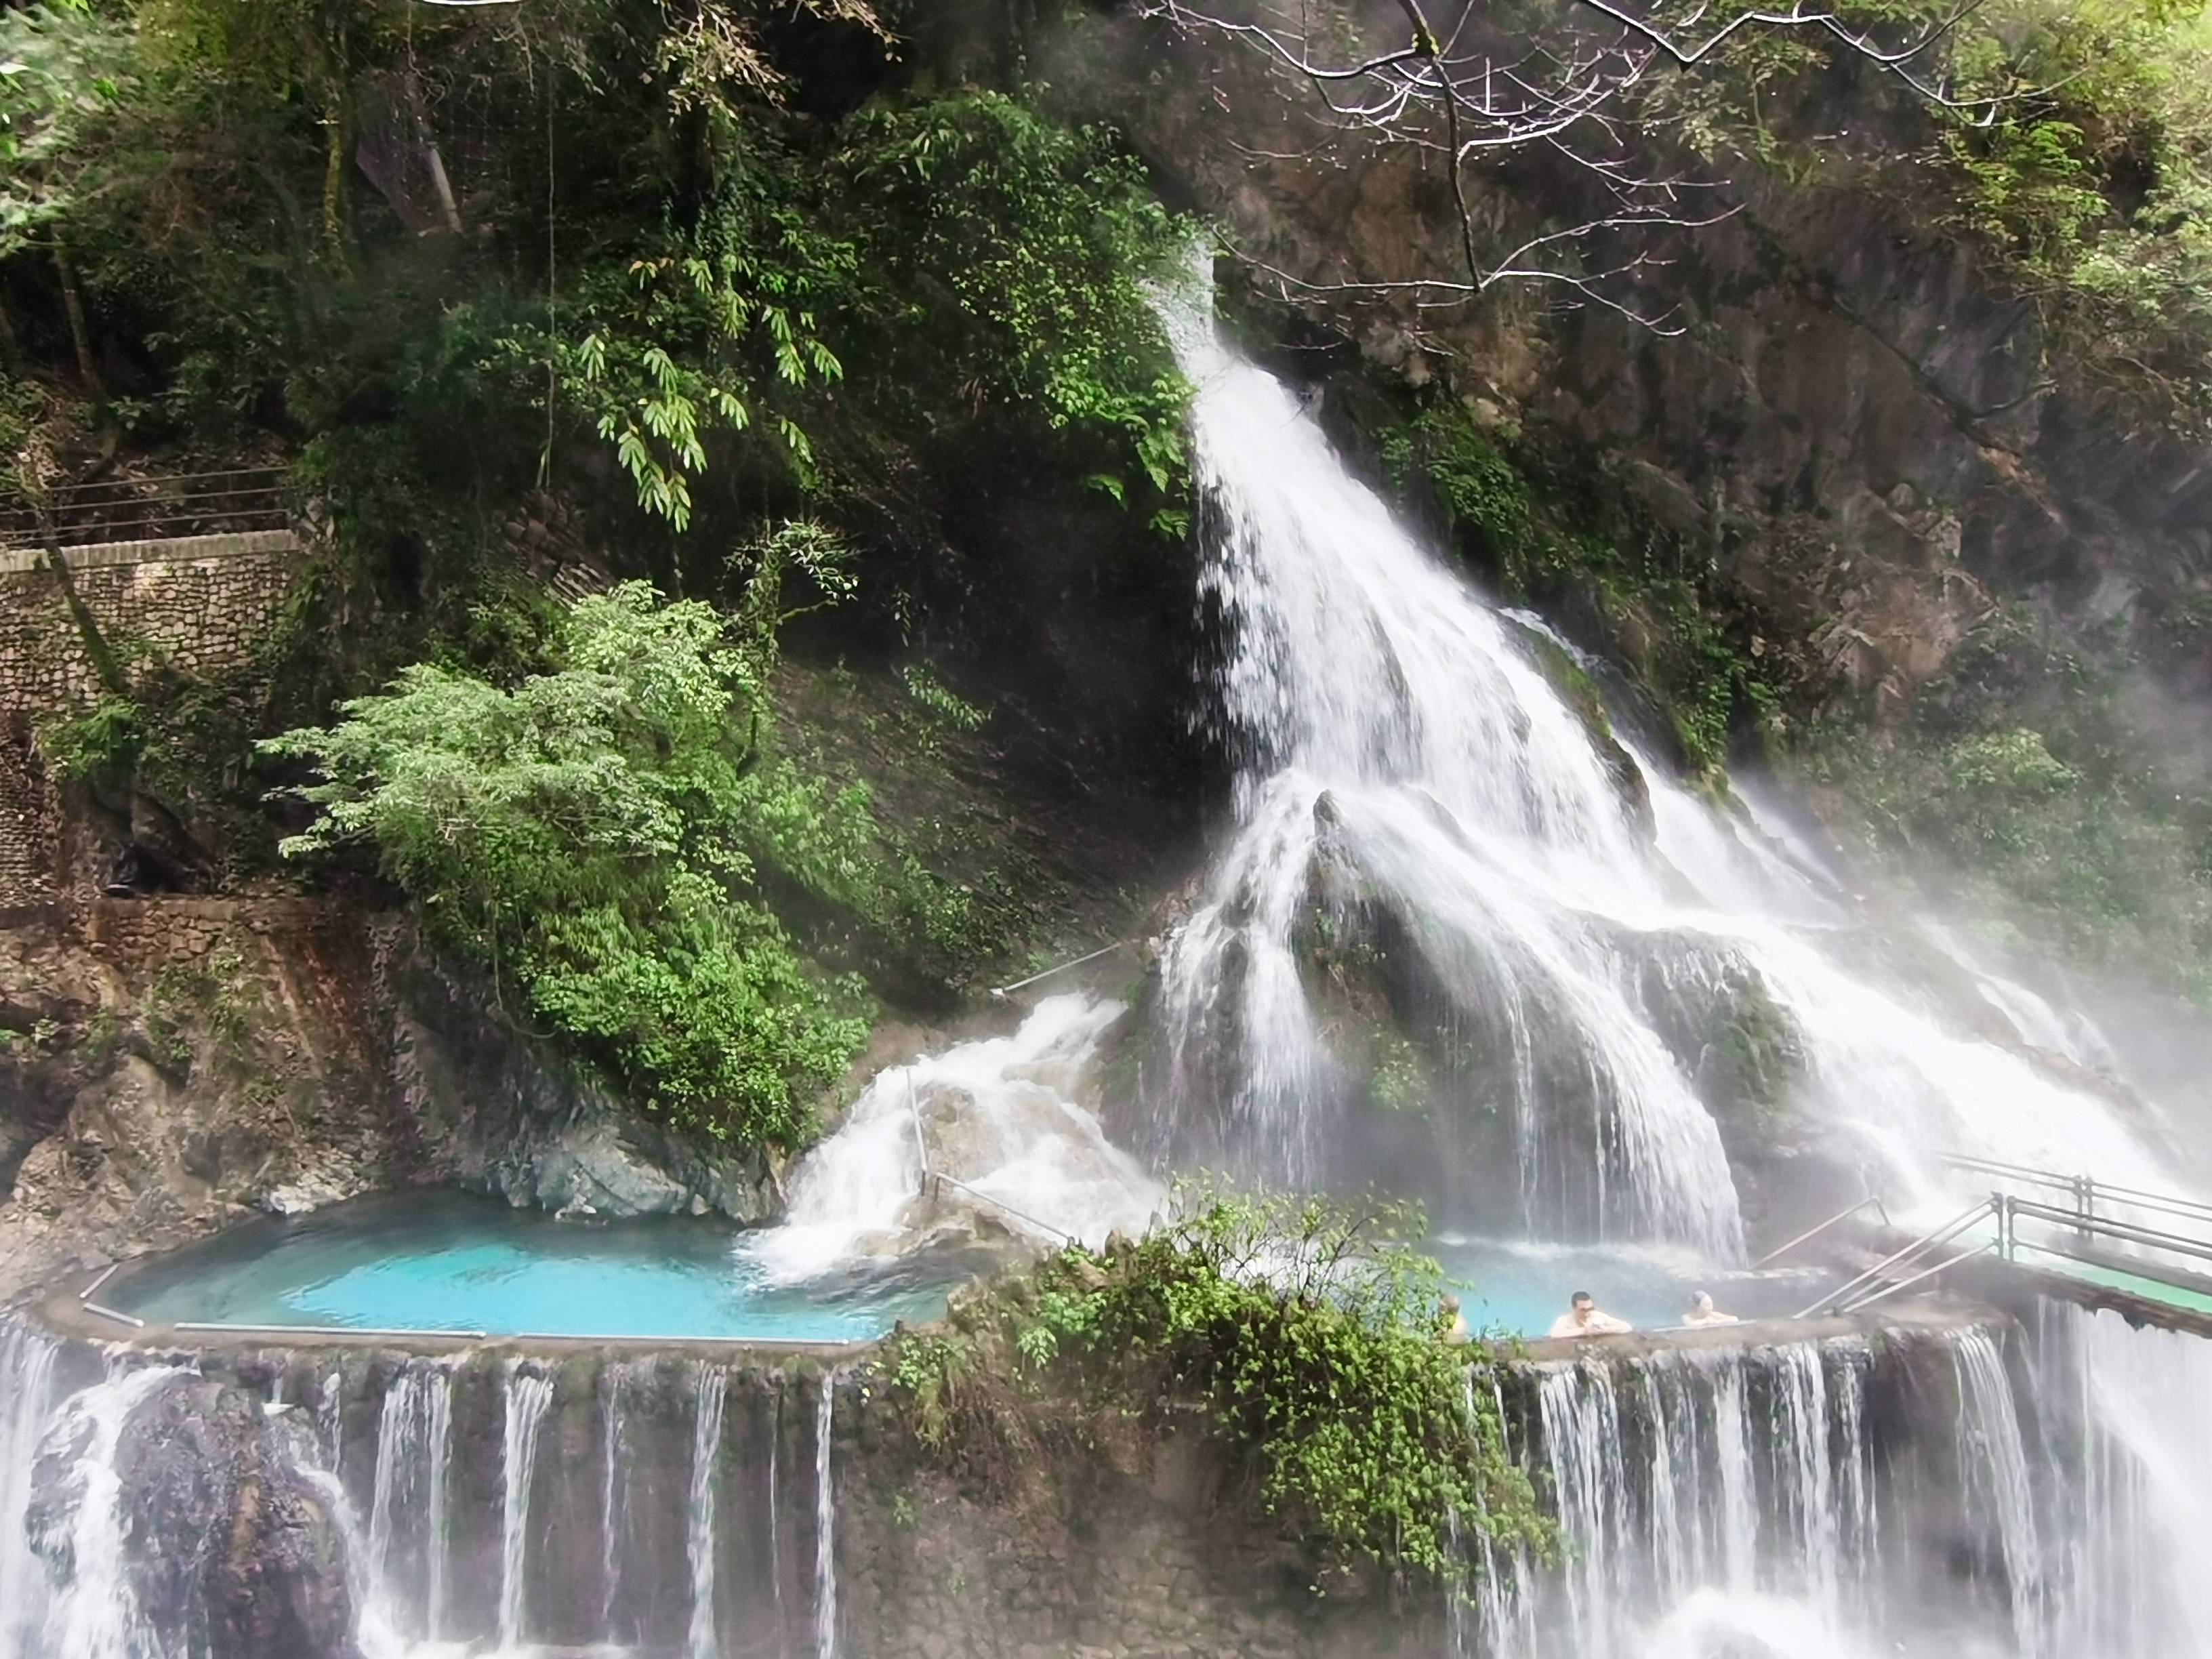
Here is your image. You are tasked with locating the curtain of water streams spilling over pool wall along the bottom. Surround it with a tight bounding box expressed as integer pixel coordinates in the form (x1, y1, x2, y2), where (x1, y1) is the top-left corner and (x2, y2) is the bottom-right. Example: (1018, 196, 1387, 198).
(0, 1307, 2212, 1659)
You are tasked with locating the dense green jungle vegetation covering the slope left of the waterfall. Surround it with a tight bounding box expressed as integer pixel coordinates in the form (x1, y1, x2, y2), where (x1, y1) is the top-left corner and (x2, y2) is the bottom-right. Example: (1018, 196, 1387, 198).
(0, 0, 1188, 1146)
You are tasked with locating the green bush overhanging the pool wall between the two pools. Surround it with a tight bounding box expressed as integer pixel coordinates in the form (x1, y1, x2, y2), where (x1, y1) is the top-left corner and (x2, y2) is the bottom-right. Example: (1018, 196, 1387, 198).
(887, 1192, 1553, 1582)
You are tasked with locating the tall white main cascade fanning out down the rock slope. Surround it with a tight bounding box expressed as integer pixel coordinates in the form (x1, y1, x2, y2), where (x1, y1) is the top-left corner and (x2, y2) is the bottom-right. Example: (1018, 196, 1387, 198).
(1148, 285, 2170, 1261)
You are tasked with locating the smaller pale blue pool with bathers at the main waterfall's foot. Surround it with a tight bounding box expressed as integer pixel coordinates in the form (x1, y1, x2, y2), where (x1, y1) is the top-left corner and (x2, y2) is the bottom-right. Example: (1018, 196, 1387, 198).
(1422, 1234, 1836, 1336)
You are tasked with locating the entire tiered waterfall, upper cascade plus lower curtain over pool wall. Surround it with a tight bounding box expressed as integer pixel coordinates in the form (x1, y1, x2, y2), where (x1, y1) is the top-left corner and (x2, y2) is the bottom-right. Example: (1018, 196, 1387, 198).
(0, 305, 2212, 1659)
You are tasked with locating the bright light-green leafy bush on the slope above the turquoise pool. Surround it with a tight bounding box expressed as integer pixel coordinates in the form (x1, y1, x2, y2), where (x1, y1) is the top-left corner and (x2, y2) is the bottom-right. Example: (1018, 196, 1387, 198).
(263, 579, 874, 1146)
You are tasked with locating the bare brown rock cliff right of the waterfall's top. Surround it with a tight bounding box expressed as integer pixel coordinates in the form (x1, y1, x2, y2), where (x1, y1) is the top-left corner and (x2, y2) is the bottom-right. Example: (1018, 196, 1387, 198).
(1026, 16, 2212, 734)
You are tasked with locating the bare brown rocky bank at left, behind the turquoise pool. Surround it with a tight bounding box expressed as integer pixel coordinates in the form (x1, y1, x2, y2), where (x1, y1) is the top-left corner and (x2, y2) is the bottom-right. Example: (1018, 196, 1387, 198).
(0, 898, 777, 1290)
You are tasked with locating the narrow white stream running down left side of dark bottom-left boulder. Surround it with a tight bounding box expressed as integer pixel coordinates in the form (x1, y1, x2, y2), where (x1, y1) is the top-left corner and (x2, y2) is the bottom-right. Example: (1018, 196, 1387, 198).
(33, 1365, 184, 1659)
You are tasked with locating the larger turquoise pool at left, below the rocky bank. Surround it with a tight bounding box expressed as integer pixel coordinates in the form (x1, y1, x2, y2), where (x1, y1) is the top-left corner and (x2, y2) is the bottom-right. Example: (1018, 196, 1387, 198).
(100, 1190, 964, 1343)
